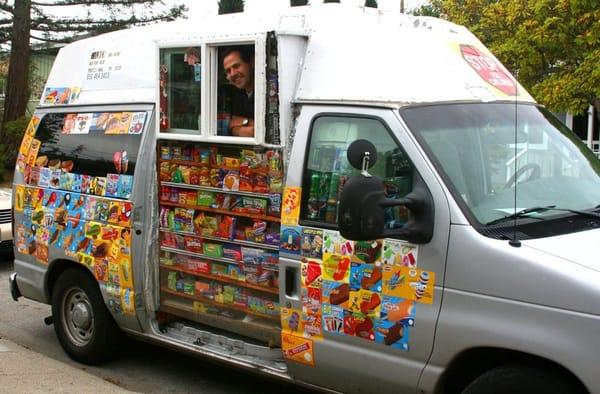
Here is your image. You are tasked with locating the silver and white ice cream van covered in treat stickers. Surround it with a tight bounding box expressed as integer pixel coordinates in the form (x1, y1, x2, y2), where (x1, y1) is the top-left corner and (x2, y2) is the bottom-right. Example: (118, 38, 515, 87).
(10, 3, 600, 393)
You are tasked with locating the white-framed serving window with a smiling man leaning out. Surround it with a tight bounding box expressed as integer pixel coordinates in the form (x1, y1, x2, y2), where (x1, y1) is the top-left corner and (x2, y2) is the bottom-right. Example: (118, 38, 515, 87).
(157, 34, 280, 145)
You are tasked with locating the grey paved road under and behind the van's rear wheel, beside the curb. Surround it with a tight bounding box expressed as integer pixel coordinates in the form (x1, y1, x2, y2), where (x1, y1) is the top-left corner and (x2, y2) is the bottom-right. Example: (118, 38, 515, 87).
(0, 258, 310, 394)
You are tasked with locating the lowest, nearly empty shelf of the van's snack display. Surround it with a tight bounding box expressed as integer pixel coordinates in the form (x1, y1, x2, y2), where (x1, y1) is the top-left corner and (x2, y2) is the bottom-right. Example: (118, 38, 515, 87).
(160, 298, 281, 347)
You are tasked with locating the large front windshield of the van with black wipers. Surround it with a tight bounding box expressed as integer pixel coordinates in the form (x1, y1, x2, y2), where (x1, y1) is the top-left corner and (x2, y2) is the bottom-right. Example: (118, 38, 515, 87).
(401, 103, 600, 235)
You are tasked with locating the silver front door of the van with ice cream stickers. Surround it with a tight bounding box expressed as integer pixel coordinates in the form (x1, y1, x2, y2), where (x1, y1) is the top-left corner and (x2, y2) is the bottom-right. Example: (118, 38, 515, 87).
(280, 106, 449, 392)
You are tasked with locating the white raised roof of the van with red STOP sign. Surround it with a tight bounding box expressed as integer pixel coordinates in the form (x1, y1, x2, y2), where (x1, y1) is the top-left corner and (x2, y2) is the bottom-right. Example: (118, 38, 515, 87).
(41, 3, 533, 107)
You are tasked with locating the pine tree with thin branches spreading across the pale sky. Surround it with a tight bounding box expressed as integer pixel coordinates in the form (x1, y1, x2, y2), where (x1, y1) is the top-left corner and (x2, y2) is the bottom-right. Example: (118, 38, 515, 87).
(0, 0, 187, 124)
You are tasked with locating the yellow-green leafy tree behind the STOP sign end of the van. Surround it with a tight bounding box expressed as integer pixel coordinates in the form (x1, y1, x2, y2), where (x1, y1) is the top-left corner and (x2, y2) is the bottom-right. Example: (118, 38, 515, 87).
(432, 0, 600, 113)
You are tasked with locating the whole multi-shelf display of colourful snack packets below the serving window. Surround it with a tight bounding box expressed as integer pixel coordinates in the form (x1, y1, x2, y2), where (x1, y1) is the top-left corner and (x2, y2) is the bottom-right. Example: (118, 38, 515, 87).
(158, 141, 283, 346)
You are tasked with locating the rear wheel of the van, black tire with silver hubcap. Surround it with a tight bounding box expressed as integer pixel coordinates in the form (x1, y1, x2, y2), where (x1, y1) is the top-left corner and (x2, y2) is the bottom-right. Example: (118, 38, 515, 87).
(52, 268, 122, 365)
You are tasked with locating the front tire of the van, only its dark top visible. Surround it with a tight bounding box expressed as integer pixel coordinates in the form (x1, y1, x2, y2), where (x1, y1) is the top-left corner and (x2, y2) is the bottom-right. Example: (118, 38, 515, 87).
(463, 365, 582, 394)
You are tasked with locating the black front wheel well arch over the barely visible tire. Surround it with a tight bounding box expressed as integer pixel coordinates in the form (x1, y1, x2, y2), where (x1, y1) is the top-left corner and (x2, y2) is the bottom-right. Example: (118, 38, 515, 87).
(435, 347, 588, 394)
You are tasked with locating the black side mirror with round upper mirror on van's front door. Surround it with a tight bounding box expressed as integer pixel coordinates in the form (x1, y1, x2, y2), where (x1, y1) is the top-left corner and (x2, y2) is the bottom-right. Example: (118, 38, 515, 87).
(338, 140, 434, 244)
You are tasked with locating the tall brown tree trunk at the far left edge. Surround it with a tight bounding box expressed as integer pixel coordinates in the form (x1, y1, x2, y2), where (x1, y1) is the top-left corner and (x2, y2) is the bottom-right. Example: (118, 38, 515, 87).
(3, 0, 31, 123)
